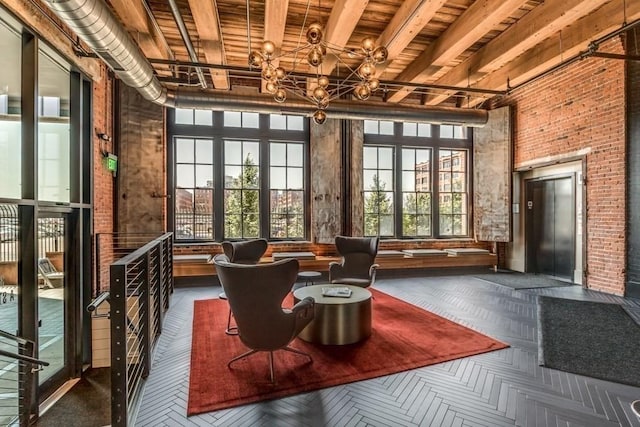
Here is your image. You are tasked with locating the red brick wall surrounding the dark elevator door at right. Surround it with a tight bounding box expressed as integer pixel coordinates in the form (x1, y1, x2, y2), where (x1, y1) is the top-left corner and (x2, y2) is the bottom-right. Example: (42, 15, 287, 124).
(500, 38, 626, 295)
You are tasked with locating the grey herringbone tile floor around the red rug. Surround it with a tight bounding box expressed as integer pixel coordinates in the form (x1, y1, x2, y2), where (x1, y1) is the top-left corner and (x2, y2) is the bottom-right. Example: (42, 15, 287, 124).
(135, 276, 640, 427)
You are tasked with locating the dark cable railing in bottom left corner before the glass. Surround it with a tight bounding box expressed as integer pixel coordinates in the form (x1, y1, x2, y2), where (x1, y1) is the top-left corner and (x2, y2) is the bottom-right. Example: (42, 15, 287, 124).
(0, 331, 49, 427)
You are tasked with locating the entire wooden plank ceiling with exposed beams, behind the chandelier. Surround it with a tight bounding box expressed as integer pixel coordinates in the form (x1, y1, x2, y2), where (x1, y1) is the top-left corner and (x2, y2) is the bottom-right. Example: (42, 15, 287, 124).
(108, 0, 640, 107)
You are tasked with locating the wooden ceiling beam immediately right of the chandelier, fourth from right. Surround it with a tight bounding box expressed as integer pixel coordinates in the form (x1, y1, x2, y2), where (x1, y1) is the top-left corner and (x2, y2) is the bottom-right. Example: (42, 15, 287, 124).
(376, 0, 447, 65)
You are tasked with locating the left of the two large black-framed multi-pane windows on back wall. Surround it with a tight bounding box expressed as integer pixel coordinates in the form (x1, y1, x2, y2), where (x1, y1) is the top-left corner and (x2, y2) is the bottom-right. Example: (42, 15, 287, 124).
(167, 109, 309, 241)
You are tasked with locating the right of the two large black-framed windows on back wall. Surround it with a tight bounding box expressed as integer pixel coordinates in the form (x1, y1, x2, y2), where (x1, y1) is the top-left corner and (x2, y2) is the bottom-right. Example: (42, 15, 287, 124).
(363, 120, 472, 238)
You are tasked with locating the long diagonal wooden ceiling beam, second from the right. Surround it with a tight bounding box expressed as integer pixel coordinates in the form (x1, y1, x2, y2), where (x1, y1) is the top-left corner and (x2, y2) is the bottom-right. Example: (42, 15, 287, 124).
(426, 0, 608, 105)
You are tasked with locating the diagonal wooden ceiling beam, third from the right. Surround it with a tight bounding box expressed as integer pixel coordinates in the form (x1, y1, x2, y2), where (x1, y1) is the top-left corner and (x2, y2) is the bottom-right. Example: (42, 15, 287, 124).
(387, 0, 526, 102)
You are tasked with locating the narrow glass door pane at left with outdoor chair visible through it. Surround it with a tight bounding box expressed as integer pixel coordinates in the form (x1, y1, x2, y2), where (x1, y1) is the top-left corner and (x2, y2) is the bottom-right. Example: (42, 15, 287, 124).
(37, 213, 70, 394)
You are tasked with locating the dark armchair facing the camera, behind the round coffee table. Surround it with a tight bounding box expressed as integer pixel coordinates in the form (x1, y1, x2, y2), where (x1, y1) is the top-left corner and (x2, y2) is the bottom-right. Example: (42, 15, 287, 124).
(329, 236, 379, 288)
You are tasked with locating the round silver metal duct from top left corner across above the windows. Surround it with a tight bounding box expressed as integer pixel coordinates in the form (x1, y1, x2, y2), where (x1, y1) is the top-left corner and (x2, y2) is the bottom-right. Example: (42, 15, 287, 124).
(46, 0, 488, 127)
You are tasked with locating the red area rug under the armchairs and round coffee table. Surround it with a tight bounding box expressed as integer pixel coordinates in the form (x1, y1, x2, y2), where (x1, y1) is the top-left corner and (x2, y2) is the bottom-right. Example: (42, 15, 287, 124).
(187, 289, 508, 415)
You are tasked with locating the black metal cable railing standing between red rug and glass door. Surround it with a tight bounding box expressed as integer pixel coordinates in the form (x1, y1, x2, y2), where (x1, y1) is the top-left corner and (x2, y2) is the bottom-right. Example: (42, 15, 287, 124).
(107, 233, 173, 427)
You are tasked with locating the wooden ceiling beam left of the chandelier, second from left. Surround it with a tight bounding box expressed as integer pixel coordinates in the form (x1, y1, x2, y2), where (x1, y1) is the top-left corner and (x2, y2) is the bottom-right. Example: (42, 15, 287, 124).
(189, 0, 229, 89)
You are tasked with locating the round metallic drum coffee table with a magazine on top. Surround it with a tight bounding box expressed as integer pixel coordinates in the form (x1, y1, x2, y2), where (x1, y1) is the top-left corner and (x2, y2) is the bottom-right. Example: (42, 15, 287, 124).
(293, 284, 371, 345)
